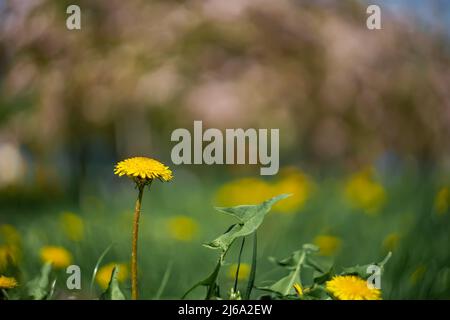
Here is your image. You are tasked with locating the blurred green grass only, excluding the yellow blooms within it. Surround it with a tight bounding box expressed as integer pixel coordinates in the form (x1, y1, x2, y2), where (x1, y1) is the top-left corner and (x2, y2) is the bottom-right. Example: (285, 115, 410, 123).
(1, 172, 450, 299)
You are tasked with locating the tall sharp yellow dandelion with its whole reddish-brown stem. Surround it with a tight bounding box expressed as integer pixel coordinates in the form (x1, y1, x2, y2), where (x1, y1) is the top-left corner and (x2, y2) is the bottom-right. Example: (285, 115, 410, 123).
(114, 157, 173, 300)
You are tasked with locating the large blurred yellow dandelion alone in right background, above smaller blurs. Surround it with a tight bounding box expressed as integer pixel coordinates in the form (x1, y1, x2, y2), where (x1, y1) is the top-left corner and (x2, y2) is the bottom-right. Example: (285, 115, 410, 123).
(345, 167, 386, 214)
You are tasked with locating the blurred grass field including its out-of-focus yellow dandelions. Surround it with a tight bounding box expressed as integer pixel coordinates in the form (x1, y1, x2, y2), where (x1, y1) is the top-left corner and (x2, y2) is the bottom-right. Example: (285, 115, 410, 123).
(0, 168, 450, 299)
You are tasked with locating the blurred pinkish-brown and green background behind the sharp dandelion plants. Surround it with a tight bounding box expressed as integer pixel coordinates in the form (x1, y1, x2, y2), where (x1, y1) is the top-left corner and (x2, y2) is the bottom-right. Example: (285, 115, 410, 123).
(0, 0, 450, 299)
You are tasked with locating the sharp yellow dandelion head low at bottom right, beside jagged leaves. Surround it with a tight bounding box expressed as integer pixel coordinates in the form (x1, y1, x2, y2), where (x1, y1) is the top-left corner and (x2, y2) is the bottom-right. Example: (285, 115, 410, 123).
(326, 276, 381, 300)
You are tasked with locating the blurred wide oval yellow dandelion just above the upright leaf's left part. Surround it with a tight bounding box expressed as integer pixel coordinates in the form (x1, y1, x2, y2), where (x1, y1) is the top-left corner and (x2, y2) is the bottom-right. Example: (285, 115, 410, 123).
(215, 178, 272, 206)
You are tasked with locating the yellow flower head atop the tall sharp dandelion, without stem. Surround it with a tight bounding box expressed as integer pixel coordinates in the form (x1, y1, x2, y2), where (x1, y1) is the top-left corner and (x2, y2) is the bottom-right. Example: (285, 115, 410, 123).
(114, 157, 173, 183)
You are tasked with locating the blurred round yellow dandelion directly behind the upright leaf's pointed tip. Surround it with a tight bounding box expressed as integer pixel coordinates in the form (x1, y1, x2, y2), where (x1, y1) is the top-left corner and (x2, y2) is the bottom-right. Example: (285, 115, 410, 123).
(271, 167, 313, 213)
